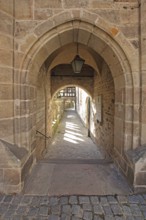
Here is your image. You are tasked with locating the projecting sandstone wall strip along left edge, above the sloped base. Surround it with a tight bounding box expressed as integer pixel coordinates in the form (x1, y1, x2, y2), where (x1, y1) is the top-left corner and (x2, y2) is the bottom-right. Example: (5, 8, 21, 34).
(0, 1, 14, 143)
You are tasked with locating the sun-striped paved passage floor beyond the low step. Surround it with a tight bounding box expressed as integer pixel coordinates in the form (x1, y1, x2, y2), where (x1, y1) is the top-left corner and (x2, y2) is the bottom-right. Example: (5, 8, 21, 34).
(45, 110, 104, 159)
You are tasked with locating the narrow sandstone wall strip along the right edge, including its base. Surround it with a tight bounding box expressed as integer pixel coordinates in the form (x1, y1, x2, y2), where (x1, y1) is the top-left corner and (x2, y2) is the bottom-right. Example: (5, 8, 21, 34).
(133, 0, 146, 189)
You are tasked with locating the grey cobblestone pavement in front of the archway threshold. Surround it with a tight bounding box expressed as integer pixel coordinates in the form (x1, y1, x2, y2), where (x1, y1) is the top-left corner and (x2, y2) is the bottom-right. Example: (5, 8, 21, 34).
(0, 194, 146, 220)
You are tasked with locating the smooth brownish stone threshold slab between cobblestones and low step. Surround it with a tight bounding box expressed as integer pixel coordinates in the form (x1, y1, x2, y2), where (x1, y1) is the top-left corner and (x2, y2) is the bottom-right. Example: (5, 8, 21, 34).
(24, 163, 131, 196)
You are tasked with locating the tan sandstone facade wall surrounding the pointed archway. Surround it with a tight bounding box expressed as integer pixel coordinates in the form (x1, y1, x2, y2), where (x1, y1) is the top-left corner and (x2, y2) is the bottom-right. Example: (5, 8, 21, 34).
(0, 0, 146, 192)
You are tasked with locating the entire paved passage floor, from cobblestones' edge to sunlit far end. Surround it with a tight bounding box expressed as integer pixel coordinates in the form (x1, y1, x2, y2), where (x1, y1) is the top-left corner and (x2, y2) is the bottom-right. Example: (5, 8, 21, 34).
(24, 111, 131, 196)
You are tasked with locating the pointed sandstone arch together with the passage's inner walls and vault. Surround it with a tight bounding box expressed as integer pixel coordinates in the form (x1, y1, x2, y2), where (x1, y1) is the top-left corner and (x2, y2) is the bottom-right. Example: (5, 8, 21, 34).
(1, 10, 144, 193)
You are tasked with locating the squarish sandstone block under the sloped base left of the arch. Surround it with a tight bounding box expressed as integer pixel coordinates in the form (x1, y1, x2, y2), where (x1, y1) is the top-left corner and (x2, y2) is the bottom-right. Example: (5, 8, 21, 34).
(4, 169, 20, 185)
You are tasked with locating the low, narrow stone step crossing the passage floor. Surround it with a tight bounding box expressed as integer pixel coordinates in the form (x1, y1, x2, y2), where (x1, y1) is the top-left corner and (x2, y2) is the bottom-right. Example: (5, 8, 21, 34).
(38, 158, 113, 165)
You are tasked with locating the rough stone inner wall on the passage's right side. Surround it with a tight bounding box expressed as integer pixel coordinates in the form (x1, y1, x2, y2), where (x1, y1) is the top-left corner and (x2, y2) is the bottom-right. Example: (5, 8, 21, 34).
(91, 63, 115, 154)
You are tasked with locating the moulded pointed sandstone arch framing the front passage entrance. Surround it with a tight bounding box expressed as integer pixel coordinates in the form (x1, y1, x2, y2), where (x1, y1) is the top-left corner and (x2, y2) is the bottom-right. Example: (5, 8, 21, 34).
(1, 10, 139, 192)
